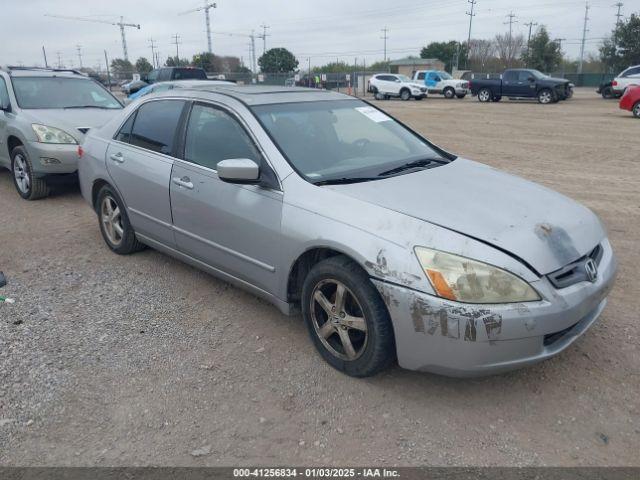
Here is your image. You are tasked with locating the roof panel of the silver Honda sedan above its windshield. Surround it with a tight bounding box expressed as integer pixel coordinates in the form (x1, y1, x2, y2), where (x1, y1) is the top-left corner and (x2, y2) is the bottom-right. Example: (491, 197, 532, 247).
(173, 82, 353, 106)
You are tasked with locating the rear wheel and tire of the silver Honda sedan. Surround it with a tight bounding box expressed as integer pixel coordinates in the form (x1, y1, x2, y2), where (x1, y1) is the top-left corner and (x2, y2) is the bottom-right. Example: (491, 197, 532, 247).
(96, 185, 144, 255)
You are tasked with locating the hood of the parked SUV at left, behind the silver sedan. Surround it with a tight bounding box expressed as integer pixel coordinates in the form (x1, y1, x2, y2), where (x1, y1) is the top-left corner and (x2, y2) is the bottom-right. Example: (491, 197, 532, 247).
(23, 108, 122, 140)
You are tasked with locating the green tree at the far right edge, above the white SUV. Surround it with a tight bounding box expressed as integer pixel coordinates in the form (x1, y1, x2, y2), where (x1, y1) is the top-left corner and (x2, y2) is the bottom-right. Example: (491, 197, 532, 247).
(600, 14, 640, 72)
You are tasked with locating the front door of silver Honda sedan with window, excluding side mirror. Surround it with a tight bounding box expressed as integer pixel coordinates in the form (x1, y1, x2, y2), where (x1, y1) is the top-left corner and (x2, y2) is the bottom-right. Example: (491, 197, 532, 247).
(171, 103, 282, 293)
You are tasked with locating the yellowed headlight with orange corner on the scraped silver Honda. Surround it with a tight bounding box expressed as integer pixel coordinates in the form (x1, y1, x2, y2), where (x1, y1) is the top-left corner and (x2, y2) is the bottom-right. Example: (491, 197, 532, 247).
(415, 247, 540, 303)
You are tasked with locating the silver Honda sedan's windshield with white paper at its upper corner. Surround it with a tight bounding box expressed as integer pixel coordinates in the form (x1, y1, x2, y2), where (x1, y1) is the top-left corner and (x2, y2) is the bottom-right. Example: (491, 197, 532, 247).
(253, 100, 453, 183)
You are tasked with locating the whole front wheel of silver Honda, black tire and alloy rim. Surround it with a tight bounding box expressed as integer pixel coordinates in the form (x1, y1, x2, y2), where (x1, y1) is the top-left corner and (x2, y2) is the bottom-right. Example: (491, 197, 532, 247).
(302, 255, 395, 377)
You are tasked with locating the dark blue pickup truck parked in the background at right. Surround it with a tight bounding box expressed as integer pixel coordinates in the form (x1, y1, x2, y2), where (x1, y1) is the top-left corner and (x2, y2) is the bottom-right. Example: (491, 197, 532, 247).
(470, 68, 573, 104)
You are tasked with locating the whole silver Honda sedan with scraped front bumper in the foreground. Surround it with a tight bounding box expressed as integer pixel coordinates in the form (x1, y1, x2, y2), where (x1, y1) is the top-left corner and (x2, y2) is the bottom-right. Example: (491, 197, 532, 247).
(79, 85, 616, 377)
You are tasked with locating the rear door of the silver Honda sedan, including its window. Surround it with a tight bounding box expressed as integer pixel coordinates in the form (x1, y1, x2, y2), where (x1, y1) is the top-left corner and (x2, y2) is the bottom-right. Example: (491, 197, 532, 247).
(106, 100, 186, 247)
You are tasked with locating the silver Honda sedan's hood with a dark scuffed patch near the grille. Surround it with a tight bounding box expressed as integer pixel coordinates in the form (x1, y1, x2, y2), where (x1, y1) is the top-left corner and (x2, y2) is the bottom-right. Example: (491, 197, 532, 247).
(327, 158, 605, 275)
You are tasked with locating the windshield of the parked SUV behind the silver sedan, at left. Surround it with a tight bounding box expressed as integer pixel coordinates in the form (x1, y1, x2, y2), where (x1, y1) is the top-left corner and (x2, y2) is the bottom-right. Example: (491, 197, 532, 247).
(11, 77, 122, 109)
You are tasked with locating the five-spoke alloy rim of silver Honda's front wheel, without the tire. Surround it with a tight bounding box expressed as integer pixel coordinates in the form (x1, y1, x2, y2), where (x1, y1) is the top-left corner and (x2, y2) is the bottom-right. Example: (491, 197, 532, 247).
(309, 279, 368, 361)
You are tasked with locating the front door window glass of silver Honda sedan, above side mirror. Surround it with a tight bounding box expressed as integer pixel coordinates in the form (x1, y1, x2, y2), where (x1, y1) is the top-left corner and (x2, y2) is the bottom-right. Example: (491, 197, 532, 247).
(184, 104, 261, 170)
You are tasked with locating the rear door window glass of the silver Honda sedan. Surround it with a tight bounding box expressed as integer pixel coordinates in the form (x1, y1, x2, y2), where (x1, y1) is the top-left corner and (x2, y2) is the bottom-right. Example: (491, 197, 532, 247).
(129, 100, 184, 155)
